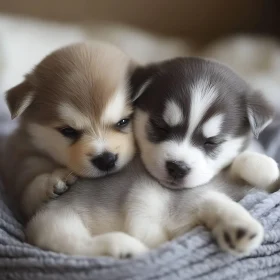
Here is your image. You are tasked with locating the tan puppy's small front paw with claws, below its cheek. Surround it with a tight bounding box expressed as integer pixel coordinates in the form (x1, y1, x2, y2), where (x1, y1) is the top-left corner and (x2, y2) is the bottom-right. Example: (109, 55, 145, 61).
(47, 168, 77, 198)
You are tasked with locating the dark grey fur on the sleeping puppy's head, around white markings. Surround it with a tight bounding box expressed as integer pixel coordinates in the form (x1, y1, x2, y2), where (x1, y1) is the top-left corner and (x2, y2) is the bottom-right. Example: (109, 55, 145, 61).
(131, 58, 273, 146)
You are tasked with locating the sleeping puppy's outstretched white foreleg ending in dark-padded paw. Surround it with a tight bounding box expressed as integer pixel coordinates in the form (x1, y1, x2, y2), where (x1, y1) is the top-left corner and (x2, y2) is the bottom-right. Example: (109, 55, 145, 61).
(197, 191, 264, 255)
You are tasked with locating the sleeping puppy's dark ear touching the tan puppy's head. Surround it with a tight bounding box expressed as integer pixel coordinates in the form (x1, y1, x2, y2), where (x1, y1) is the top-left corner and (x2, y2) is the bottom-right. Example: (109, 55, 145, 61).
(130, 64, 157, 102)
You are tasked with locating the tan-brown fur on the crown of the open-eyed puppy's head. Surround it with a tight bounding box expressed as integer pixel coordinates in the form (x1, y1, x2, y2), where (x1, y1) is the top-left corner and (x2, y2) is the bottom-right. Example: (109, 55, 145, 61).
(7, 43, 131, 123)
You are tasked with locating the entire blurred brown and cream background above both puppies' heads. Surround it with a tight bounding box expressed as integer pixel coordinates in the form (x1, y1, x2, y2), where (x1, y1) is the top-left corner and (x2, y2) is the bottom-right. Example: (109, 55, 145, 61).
(0, 0, 280, 110)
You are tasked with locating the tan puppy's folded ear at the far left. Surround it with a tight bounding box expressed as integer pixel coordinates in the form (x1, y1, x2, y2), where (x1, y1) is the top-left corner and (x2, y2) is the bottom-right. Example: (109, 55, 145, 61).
(6, 80, 34, 119)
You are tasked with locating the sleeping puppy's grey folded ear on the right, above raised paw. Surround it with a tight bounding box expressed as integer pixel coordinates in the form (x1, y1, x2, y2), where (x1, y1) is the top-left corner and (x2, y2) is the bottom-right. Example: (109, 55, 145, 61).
(247, 92, 274, 138)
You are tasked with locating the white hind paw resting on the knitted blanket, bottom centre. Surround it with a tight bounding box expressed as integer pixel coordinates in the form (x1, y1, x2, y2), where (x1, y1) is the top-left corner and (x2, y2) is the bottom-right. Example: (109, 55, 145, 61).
(107, 232, 149, 259)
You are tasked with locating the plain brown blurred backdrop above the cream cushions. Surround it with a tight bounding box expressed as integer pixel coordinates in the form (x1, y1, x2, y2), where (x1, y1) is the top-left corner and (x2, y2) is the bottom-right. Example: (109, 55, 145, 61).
(0, 0, 280, 42)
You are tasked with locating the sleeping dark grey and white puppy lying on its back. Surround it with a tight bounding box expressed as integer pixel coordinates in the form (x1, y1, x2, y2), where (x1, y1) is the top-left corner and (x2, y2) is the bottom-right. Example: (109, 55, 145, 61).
(26, 58, 279, 258)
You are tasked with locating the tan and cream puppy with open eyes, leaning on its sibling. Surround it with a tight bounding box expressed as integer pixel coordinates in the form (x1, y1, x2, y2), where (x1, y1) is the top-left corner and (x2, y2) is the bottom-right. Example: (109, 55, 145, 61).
(4, 43, 135, 218)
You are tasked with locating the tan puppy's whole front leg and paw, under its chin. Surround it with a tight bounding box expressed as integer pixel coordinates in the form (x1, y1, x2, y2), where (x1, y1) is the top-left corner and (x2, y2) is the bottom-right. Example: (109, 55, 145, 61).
(22, 168, 77, 217)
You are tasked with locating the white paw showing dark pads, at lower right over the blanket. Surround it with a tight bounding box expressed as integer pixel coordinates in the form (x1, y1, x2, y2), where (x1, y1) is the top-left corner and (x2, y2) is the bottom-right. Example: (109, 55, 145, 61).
(213, 216, 264, 255)
